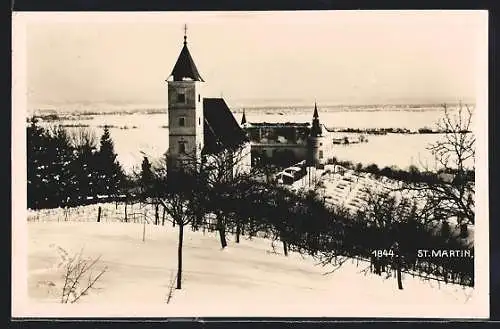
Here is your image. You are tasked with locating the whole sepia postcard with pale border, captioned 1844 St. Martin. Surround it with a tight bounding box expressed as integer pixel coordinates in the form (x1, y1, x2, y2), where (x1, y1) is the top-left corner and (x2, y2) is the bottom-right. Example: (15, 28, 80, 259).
(12, 10, 489, 319)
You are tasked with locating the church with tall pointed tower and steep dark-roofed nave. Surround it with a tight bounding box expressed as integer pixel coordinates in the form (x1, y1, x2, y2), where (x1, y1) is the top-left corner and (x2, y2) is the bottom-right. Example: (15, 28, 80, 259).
(166, 27, 251, 174)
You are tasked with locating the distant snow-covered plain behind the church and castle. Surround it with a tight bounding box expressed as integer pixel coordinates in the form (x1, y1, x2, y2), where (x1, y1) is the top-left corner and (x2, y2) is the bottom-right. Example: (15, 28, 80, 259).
(36, 109, 460, 173)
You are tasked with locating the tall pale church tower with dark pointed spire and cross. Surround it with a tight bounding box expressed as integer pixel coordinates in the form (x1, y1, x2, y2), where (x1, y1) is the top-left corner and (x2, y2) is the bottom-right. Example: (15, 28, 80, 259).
(166, 26, 204, 171)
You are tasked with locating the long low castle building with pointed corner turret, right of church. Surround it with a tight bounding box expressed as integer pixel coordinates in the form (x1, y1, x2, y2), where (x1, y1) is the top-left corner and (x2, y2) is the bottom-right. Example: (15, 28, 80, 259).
(242, 103, 333, 166)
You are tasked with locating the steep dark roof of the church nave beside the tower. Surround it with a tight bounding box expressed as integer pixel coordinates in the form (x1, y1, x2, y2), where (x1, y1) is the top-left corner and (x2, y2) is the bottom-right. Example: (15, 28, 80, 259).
(203, 98, 248, 154)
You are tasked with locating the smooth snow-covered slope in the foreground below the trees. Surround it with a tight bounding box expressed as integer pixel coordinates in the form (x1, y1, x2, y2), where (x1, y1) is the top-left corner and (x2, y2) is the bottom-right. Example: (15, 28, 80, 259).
(19, 215, 482, 317)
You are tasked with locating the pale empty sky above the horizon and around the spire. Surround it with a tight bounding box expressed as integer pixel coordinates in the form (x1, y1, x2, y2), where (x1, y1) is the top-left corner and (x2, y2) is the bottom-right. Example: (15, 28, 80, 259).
(20, 11, 487, 108)
